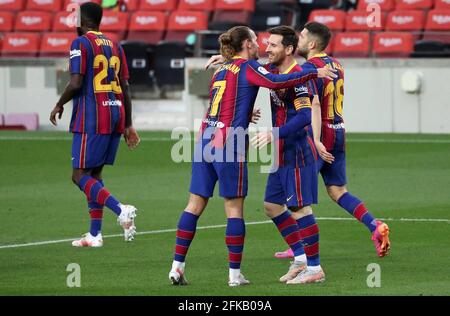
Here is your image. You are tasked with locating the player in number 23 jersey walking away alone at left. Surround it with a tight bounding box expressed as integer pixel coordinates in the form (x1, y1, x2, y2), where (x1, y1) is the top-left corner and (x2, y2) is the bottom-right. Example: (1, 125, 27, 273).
(50, 2, 140, 247)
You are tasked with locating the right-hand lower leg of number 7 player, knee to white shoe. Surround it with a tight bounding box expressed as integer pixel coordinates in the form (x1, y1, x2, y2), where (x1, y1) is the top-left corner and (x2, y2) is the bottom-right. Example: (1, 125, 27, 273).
(224, 197, 250, 286)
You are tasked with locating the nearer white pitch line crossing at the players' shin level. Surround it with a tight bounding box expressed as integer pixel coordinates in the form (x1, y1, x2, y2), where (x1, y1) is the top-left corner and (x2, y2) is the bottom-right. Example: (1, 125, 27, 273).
(0, 217, 450, 249)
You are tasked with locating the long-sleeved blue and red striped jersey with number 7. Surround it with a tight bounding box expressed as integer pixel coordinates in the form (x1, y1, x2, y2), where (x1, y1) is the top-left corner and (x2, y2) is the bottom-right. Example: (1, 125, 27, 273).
(199, 56, 317, 151)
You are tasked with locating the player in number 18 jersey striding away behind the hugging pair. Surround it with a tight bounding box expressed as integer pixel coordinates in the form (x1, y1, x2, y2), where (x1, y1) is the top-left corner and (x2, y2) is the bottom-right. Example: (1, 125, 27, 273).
(274, 22, 390, 257)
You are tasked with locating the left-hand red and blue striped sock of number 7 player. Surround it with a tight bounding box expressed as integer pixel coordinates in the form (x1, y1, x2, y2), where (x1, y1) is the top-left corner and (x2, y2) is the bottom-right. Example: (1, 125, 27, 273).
(173, 211, 198, 262)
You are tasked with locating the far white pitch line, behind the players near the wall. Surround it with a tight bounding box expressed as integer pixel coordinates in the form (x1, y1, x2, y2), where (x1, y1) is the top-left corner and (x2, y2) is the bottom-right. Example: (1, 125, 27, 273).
(0, 136, 450, 144)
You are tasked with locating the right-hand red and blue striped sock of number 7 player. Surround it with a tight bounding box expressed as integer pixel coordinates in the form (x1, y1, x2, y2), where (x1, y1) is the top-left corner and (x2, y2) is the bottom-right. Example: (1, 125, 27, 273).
(225, 218, 245, 269)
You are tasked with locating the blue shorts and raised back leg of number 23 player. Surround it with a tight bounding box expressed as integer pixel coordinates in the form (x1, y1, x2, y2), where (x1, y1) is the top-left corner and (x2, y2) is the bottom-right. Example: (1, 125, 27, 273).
(72, 133, 136, 241)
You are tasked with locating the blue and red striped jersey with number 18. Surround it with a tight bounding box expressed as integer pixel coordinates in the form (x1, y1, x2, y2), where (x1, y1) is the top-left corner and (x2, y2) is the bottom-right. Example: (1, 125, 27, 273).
(305, 53, 345, 151)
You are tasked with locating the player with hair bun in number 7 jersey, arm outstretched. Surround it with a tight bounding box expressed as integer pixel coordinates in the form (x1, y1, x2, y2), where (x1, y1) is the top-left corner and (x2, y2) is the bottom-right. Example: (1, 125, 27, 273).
(169, 26, 334, 286)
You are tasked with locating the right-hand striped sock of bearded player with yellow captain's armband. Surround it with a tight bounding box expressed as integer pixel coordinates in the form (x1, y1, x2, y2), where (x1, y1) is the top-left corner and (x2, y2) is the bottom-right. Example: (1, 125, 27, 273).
(297, 214, 320, 266)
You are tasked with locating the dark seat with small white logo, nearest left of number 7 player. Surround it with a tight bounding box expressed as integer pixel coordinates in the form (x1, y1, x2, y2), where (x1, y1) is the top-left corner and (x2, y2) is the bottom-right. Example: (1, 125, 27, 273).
(155, 42, 186, 89)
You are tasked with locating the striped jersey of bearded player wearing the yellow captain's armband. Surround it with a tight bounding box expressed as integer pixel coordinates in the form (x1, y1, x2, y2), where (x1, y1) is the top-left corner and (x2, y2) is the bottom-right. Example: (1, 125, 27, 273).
(266, 60, 317, 167)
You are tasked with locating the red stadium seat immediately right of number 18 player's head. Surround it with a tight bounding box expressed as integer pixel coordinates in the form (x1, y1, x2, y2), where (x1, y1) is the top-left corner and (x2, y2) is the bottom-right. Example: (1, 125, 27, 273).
(333, 32, 370, 57)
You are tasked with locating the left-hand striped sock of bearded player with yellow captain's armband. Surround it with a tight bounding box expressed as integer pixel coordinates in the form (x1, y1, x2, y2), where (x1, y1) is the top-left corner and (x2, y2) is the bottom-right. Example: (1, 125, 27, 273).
(272, 210, 305, 257)
